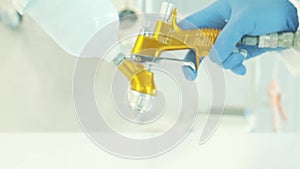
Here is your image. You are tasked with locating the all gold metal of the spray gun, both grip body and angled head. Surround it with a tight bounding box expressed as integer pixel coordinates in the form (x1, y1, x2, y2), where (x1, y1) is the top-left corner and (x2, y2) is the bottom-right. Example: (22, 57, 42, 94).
(119, 9, 220, 96)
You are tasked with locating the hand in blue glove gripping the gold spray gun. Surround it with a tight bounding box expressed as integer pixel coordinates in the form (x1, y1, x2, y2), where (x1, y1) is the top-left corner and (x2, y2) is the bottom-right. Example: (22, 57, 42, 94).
(180, 0, 299, 80)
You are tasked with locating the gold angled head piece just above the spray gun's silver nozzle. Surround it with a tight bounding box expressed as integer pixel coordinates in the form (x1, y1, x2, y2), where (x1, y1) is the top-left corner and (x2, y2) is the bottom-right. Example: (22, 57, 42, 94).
(118, 59, 156, 96)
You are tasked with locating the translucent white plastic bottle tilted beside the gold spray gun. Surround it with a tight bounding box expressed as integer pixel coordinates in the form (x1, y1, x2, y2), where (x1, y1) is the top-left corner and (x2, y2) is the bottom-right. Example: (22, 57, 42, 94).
(14, 0, 119, 60)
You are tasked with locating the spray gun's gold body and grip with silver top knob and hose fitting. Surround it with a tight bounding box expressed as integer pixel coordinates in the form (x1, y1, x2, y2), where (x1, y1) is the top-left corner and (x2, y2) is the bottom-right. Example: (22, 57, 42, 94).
(135, 2, 300, 69)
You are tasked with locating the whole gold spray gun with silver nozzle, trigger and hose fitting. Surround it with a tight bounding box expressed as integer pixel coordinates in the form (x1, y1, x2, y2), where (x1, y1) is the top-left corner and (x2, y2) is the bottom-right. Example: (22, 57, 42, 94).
(113, 2, 300, 113)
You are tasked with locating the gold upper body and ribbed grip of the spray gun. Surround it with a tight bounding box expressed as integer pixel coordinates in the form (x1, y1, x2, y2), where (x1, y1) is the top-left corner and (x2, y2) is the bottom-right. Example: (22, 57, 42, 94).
(132, 9, 220, 69)
